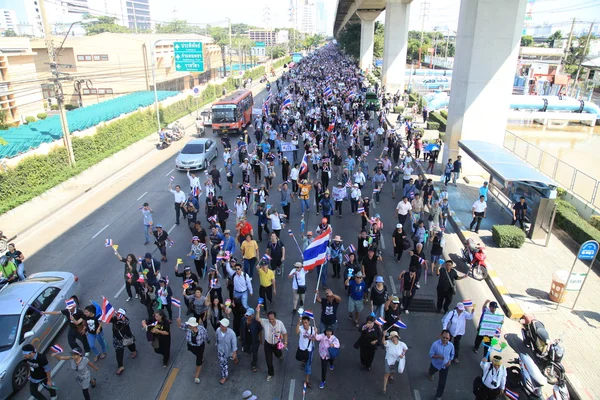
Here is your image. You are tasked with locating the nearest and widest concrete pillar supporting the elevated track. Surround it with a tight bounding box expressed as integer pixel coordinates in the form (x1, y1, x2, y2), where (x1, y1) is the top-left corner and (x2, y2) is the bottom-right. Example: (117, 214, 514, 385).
(440, 0, 527, 168)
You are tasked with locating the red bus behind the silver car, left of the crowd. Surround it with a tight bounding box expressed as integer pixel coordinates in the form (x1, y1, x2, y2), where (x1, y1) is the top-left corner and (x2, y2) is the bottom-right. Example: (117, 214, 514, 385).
(212, 90, 254, 133)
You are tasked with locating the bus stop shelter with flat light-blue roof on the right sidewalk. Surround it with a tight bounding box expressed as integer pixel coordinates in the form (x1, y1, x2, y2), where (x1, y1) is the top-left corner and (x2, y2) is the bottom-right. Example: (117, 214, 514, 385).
(458, 140, 557, 239)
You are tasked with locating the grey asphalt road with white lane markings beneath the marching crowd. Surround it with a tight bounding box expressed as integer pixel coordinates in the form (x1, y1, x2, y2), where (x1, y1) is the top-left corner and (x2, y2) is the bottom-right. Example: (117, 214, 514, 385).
(10, 85, 514, 400)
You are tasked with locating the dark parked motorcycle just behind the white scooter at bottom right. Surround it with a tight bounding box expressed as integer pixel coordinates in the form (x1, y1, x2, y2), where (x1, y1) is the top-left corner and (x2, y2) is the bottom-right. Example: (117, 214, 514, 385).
(520, 314, 565, 384)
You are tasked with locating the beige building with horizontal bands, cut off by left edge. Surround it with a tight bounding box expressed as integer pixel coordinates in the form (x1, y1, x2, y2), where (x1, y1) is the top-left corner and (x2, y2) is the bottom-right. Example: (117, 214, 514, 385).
(0, 37, 44, 123)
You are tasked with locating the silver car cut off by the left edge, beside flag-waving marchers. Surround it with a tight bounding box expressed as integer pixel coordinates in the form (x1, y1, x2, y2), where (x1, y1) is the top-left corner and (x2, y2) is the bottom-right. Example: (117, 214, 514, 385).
(0, 271, 79, 399)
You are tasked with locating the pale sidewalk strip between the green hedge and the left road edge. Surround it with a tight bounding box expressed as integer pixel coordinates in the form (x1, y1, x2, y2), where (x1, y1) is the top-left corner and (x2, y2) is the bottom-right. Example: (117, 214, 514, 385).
(0, 68, 283, 238)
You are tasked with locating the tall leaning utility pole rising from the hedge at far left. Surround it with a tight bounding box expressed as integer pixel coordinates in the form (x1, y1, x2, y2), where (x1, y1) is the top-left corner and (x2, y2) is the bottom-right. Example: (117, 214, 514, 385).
(38, 0, 75, 167)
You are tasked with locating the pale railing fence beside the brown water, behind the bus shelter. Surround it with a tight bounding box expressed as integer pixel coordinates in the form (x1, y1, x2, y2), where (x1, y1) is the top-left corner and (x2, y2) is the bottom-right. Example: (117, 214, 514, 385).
(504, 131, 600, 209)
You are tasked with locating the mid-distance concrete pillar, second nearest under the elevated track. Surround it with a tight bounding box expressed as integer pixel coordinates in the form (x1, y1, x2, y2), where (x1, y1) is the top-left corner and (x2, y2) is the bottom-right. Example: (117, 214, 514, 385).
(381, 0, 412, 93)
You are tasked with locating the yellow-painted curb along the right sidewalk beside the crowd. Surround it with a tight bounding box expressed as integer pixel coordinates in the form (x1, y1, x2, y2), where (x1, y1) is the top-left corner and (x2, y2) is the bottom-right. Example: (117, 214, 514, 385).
(385, 114, 524, 319)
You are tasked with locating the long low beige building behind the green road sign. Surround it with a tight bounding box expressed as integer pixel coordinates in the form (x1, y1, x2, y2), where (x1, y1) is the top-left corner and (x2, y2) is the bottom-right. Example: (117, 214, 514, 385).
(31, 33, 222, 106)
